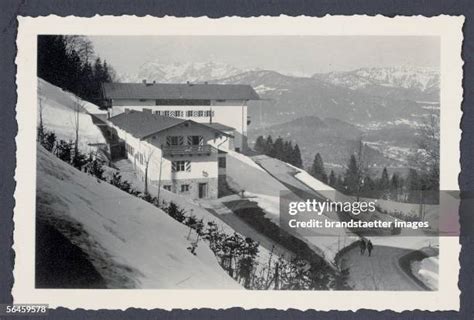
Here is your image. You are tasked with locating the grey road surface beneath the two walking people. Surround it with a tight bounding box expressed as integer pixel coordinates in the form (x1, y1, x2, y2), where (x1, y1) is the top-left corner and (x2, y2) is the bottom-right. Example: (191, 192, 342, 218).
(341, 245, 425, 291)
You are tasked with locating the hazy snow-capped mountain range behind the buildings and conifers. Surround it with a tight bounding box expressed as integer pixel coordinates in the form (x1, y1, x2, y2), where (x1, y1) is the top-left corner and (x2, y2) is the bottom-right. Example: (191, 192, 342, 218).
(117, 62, 439, 174)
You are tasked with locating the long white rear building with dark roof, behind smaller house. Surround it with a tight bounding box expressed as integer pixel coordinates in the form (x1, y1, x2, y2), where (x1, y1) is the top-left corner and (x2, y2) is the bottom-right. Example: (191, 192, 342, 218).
(103, 81, 260, 152)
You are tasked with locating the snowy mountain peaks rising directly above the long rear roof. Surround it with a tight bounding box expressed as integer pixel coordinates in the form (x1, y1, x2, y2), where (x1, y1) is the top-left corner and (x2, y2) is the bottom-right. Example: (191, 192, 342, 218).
(131, 61, 243, 83)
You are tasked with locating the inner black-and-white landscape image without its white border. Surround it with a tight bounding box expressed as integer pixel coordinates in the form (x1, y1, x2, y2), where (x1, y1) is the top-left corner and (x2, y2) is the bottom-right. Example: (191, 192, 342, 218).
(35, 34, 440, 291)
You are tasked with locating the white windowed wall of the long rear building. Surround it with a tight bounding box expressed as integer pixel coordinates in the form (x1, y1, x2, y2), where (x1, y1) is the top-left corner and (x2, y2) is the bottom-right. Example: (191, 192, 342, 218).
(111, 100, 248, 151)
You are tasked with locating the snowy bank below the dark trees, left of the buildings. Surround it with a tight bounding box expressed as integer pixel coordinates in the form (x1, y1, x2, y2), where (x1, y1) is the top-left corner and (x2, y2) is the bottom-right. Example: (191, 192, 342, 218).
(37, 78, 105, 152)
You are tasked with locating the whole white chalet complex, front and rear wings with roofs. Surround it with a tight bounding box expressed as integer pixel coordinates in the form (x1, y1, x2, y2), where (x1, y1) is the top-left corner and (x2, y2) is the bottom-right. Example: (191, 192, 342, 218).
(103, 83, 259, 199)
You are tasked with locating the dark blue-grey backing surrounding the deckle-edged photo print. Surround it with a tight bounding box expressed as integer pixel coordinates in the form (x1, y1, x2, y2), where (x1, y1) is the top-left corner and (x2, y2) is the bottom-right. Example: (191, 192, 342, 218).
(0, 0, 474, 320)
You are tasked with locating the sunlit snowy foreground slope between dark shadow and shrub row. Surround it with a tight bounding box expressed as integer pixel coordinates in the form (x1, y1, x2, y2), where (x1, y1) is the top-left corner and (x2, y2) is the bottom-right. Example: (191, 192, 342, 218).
(37, 147, 241, 289)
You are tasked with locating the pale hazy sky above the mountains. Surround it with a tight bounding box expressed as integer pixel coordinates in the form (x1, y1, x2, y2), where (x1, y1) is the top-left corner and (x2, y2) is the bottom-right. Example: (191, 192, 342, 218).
(89, 36, 440, 76)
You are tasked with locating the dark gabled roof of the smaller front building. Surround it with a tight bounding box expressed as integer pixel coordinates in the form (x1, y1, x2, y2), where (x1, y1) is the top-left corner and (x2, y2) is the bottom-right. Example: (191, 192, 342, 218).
(109, 110, 231, 139)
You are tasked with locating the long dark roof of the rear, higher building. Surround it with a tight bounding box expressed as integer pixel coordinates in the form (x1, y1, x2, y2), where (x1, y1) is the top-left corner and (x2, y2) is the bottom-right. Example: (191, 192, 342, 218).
(102, 83, 260, 100)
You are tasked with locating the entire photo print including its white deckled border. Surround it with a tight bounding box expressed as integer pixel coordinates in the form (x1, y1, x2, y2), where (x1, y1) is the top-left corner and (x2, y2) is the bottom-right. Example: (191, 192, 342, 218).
(9, 16, 464, 313)
